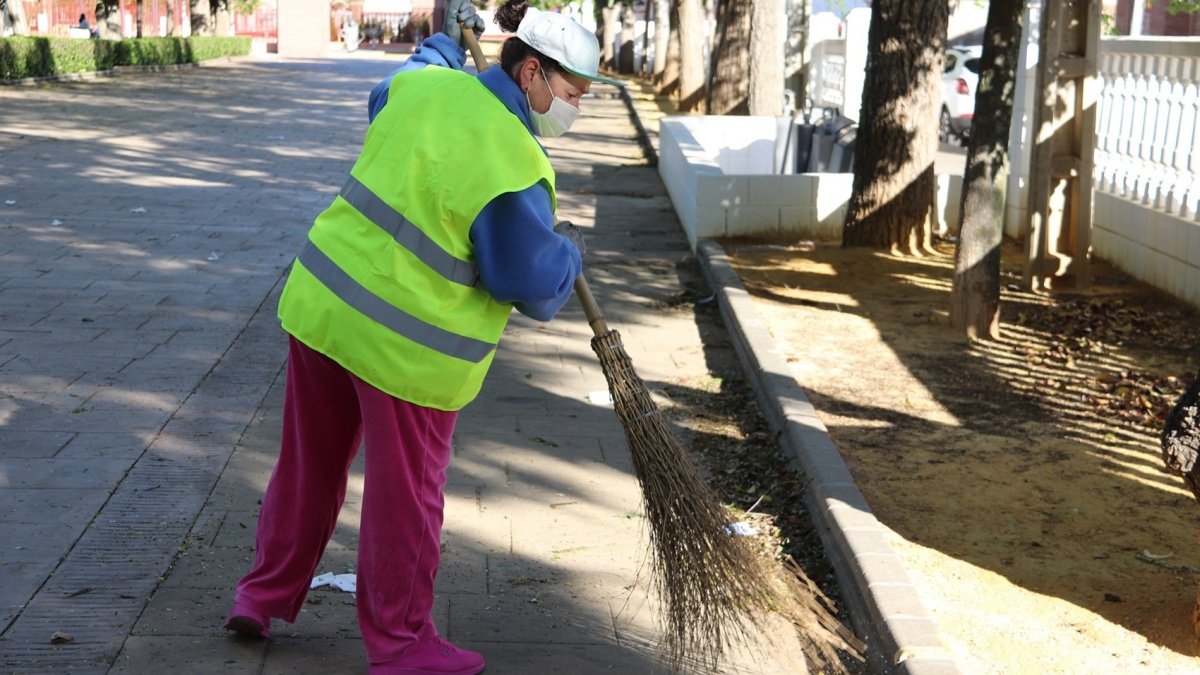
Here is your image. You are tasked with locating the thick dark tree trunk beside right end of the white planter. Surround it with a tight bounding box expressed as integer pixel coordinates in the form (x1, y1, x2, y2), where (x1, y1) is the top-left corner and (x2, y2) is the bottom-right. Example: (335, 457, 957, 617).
(842, 0, 949, 255)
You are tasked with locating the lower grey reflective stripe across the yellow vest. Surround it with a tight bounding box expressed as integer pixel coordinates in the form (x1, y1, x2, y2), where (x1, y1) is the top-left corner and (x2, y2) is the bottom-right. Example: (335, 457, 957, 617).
(299, 241, 496, 363)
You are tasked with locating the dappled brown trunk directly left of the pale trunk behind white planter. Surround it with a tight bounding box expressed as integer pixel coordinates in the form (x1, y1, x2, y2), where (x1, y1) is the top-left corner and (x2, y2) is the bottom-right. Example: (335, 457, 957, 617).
(708, 0, 751, 115)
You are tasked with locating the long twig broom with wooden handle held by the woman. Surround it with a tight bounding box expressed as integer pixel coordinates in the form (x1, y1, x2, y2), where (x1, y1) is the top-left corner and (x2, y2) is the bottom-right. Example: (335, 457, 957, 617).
(462, 26, 862, 670)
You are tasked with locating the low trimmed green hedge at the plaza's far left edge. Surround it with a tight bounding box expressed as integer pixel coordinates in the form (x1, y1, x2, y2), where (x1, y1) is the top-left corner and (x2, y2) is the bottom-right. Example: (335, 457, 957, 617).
(0, 36, 250, 80)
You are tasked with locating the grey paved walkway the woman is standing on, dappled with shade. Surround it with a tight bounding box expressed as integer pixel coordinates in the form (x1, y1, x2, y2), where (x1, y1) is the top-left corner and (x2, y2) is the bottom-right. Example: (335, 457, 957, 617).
(0, 54, 804, 674)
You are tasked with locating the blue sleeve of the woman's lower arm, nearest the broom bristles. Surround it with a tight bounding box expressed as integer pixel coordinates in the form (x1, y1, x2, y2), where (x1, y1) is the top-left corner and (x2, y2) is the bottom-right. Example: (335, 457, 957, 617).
(470, 185, 583, 321)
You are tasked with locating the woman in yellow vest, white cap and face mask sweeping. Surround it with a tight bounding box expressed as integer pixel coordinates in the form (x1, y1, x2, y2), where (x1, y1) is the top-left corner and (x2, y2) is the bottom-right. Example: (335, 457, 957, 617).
(226, 0, 619, 675)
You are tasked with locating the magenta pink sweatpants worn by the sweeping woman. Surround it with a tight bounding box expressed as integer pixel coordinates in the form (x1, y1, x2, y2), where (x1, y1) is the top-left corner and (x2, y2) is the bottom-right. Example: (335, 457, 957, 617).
(236, 338, 457, 663)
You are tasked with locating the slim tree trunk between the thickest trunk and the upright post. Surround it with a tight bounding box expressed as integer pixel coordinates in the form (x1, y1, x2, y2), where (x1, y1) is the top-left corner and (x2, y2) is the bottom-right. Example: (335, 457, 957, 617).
(950, 0, 1025, 340)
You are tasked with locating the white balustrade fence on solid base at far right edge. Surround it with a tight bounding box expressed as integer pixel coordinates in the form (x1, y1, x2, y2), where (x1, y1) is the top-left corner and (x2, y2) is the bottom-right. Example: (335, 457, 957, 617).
(1092, 37, 1200, 306)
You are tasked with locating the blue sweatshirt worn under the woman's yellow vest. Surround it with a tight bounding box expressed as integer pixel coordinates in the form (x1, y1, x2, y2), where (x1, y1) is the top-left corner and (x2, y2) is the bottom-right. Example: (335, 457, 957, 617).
(367, 32, 583, 321)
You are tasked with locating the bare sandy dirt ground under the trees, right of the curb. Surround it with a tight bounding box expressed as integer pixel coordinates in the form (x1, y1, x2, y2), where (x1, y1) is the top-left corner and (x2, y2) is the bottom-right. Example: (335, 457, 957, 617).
(726, 243, 1200, 674)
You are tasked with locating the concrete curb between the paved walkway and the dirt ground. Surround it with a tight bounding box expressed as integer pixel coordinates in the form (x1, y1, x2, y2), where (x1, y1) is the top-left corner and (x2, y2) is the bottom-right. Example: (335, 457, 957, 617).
(609, 78, 961, 675)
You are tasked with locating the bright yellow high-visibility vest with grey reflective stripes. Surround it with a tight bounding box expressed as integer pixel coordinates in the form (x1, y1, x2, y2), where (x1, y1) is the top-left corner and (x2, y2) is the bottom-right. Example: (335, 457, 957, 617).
(278, 67, 556, 411)
